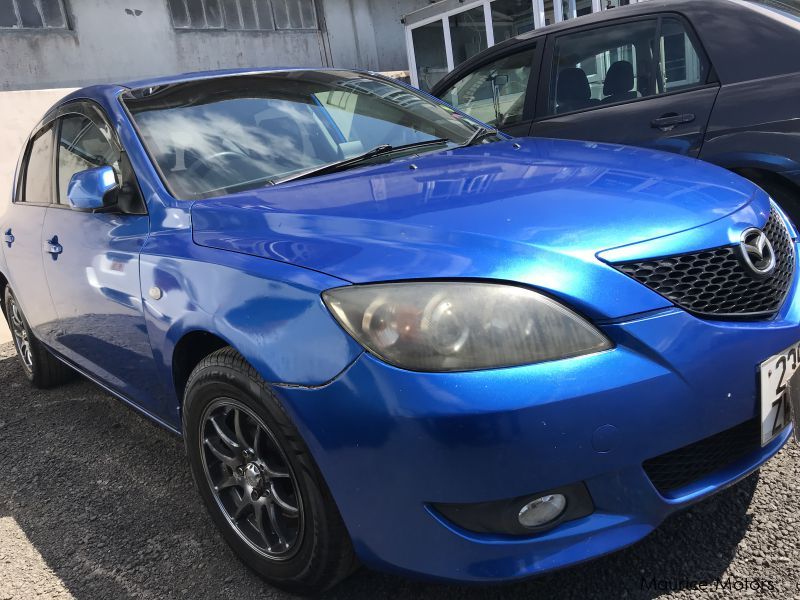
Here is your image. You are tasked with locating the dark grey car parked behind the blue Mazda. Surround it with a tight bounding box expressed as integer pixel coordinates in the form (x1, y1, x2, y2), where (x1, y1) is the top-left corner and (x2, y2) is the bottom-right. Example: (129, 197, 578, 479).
(431, 0, 800, 222)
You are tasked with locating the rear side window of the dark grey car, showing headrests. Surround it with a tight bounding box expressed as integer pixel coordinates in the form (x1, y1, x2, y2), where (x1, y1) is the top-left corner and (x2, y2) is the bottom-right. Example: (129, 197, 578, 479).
(548, 17, 709, 115)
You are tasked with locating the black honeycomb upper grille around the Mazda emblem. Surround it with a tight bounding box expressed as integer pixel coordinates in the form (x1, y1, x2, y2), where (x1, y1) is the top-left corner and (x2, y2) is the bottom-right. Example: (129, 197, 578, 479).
(614, 210, 795, 318)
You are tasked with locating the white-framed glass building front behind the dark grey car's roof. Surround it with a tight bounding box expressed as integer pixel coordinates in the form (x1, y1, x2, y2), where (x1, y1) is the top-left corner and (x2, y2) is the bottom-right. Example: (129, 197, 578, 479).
(403, 0, 639, 90)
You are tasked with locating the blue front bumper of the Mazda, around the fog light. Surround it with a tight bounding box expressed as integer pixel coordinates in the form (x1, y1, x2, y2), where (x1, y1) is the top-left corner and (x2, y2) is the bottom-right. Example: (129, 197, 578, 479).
(278, 276, 800, 581)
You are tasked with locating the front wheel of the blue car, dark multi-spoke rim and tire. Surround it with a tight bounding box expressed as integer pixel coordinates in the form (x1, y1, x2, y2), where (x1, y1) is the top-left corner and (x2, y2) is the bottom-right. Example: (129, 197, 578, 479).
(183, 348, 357, 594)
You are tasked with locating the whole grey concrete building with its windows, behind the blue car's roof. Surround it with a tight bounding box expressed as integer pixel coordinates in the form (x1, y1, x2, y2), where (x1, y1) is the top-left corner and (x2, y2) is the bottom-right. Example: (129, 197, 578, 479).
(0, 0, 429, 90)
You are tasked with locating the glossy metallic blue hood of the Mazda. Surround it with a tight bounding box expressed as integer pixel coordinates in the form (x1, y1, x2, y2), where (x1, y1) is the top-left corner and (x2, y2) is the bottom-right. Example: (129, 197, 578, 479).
(192, 139, 769, 317)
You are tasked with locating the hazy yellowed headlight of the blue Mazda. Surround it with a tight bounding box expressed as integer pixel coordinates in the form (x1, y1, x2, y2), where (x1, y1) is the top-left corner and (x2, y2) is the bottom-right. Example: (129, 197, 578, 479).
(322, 281, 612, 371)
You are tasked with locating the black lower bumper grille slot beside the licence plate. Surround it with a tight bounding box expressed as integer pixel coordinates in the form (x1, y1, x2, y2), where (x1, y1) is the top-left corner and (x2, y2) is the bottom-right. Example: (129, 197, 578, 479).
(642, 419, 761, 496)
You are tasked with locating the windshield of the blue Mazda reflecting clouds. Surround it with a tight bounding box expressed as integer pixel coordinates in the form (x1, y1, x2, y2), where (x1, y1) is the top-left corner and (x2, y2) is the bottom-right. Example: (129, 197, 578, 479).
(123, 71, 488, 199)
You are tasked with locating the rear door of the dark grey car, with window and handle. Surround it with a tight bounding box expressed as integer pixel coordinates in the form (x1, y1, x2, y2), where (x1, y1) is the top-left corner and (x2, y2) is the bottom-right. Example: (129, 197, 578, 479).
(531, 14, 719, 156)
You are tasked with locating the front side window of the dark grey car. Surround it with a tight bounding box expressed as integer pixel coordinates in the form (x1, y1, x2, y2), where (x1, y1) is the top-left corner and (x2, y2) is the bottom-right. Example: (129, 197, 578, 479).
(436, 41, 542, 135)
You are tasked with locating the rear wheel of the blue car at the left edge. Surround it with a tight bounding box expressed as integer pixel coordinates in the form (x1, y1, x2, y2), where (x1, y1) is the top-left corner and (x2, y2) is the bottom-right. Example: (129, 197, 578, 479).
(3, 286, 75, 389)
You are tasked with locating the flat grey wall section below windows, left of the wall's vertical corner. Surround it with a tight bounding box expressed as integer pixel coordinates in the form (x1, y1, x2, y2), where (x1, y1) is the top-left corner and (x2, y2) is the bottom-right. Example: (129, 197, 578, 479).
(0, 0, 326, 90)
